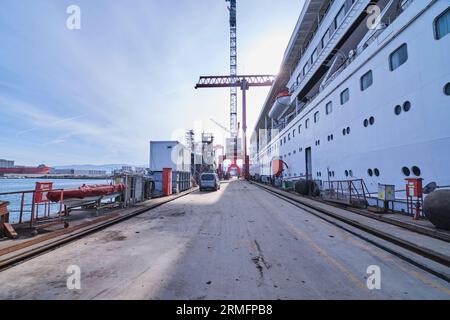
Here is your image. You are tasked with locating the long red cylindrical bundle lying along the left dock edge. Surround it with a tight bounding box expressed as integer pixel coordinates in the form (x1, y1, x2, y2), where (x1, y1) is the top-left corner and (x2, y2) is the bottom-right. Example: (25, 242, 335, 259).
(47, 183, 126, 202)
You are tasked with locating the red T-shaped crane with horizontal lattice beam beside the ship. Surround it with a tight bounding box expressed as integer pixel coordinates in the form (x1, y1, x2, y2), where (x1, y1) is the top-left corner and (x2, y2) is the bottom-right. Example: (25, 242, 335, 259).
(195, 75, 275, 178)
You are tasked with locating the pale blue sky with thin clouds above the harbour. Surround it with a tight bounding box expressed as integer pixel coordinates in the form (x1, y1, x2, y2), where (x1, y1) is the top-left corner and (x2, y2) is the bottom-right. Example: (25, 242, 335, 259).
(0, 0, 303, 165)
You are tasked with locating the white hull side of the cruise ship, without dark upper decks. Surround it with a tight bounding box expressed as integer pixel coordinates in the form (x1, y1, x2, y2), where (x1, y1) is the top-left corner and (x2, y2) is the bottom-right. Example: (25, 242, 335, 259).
(251, 0, 450, 199)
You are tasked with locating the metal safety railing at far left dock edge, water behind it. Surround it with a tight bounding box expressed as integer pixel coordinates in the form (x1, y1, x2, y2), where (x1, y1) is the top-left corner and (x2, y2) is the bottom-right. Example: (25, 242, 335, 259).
(0, 189, 67, 228)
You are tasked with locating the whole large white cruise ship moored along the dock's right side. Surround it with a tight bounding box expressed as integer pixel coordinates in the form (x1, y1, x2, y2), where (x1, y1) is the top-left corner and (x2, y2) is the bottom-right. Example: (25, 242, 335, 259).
(250, 0, 450, 198)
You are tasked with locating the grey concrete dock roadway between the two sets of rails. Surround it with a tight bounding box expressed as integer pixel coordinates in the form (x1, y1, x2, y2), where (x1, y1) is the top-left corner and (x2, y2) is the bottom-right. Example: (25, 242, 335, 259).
(0, 181, 450, 300)
